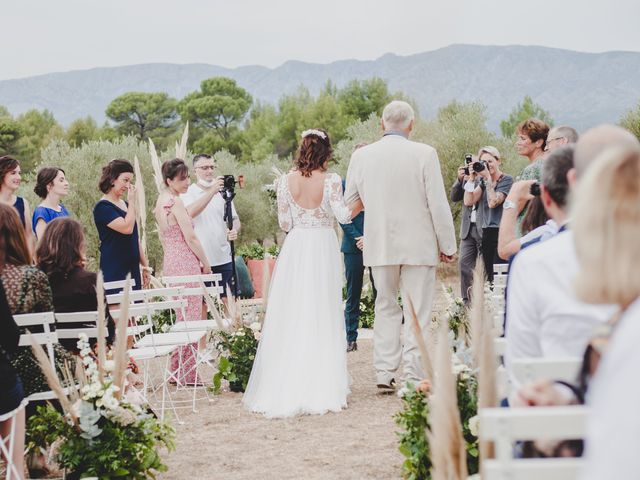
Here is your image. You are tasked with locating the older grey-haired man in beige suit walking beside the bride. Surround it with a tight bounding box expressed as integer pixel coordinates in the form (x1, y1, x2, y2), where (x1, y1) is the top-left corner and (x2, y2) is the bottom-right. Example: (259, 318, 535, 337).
(345, 101, 456, 389)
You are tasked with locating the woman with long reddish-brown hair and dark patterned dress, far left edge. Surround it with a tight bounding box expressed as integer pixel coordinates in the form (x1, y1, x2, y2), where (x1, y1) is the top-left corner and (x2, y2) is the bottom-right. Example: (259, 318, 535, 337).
(0, 205, 72, 396)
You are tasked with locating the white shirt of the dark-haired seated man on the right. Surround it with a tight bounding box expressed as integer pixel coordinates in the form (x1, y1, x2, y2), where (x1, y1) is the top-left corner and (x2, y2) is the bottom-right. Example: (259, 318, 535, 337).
(505, 231, 616, 389)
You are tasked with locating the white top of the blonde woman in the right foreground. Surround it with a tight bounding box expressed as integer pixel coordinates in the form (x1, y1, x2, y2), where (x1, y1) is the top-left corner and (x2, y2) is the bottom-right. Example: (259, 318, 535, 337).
(580, 300, 640, 480)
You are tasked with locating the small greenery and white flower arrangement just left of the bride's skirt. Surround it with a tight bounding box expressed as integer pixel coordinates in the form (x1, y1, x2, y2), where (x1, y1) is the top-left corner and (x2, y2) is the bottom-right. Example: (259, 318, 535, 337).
(213, 321, 262, 394)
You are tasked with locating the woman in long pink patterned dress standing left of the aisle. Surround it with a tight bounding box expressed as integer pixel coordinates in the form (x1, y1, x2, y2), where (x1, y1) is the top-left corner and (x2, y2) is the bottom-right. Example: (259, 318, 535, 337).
(154, 158, 211, 385)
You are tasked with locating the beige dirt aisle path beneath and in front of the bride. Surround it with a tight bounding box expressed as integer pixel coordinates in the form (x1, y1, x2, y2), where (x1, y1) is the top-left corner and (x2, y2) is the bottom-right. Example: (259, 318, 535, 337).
(159, 282, 453, 480)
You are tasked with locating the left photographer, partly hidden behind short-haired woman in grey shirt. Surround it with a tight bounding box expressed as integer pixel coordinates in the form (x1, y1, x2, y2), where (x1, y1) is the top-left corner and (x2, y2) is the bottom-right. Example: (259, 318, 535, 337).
(449, 161, 482, 305)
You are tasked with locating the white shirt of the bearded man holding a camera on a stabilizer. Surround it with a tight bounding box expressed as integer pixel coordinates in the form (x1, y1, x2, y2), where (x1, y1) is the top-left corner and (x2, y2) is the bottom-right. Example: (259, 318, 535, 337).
(180, 183, 238, 267)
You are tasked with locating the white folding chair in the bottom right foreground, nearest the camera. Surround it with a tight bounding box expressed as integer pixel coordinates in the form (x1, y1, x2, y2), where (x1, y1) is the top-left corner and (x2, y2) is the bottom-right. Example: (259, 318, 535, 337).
(479, 406, 589, 480)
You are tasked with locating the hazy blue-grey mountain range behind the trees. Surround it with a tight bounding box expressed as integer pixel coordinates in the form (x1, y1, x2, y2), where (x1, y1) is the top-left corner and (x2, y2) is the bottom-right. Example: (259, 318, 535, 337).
(0, 45, 640, 131)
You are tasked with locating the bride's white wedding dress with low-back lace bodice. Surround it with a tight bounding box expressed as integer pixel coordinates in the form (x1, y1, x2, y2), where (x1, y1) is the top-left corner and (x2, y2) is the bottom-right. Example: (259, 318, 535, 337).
(242, 173, 351, 418)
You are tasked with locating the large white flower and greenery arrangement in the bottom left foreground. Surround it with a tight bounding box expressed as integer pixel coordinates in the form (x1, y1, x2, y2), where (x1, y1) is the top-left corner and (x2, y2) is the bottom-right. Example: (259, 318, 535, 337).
(27, 334, 175, 479)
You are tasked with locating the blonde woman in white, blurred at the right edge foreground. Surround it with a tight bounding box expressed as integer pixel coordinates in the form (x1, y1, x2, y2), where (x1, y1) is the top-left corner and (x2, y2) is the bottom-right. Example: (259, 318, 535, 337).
(572, 146, 640, 480)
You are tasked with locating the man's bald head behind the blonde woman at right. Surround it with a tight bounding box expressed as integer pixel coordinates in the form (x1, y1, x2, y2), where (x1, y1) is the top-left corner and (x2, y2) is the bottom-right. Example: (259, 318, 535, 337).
(573, 125, 640, 178)
